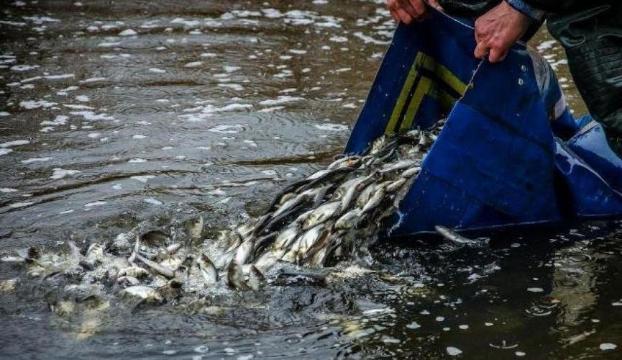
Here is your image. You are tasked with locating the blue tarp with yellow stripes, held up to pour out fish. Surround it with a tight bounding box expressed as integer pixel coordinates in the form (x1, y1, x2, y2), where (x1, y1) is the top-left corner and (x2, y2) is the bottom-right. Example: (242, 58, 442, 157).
(345, 11, 622, 236)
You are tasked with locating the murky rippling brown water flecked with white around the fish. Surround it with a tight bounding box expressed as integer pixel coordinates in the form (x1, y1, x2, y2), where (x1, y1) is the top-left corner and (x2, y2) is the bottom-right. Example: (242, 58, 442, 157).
(0, 0, 622, 359)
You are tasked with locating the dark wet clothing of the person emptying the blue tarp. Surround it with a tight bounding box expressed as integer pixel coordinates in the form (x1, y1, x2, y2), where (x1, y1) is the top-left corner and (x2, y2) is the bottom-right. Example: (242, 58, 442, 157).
(439, 0, 622, 154)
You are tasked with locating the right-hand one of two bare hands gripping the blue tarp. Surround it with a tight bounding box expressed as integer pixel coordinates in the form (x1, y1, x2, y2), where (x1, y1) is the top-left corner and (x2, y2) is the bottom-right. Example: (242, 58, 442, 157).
(474, 1, 531, 63)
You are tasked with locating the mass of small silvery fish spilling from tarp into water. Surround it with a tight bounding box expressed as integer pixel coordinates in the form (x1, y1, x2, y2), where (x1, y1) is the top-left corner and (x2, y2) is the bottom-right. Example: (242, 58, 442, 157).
(1, 124, 443, 311)
